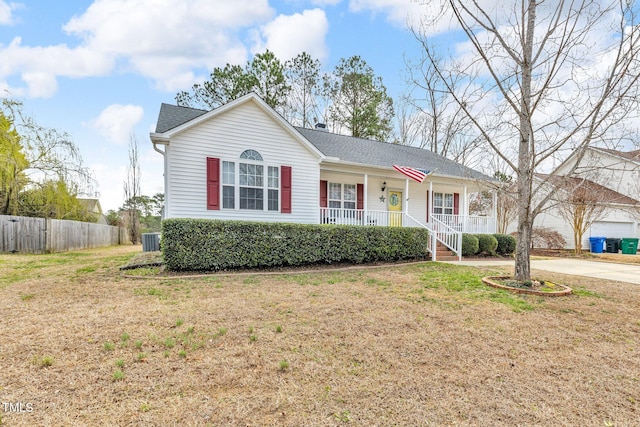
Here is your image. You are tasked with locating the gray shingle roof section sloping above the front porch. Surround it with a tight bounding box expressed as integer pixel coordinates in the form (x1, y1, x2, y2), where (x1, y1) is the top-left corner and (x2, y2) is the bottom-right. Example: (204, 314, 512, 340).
(296, 127, 494, 181)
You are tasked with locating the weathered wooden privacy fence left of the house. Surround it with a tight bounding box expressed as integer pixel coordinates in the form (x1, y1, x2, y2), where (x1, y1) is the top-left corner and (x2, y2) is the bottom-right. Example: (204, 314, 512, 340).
(0, 215, 126, 254)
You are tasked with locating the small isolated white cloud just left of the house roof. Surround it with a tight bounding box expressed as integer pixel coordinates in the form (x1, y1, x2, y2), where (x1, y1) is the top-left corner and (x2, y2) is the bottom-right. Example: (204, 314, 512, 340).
(91, 104, 144, 145)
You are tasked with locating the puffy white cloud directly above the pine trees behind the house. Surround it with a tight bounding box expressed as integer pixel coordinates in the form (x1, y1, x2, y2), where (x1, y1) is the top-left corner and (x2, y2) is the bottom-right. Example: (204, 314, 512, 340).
(254, 9, 329, 61)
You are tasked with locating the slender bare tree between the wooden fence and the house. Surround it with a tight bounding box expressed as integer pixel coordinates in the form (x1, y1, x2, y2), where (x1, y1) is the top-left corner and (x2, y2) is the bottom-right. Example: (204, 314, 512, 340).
(124, 135, 141, 245)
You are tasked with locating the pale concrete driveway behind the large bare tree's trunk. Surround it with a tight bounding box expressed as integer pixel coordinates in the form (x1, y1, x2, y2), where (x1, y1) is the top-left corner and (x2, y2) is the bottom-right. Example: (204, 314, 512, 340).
(449, 255, 640, 285)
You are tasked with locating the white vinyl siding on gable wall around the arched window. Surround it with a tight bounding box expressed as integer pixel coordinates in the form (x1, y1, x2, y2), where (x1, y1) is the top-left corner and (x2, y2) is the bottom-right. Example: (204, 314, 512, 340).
(165, 101, 320, 223)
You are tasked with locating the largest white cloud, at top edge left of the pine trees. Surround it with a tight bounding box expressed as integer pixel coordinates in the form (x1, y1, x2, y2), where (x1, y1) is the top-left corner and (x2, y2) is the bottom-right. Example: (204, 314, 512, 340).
(64, 0, 274, 91)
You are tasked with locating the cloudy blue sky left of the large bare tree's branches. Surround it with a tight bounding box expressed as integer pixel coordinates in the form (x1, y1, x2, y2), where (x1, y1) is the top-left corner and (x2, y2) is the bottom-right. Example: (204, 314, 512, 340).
(0, 0, 436, 212)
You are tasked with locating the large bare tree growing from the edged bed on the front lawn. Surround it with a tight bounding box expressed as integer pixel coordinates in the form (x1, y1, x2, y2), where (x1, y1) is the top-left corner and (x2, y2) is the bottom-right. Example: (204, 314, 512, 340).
(416, 0, 640, 280)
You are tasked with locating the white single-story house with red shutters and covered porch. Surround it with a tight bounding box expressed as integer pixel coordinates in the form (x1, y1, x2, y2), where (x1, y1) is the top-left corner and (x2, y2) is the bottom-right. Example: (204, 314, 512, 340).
(150, 94, 496, 257)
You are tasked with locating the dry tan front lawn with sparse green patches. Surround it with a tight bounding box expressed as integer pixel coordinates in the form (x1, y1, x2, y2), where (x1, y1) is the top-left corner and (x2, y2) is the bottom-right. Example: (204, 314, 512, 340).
(0, 247, 640, 426)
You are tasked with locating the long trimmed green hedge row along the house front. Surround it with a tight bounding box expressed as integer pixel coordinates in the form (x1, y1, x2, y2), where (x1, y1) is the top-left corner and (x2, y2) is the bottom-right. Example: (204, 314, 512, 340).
(161, 219, 429, 271)
